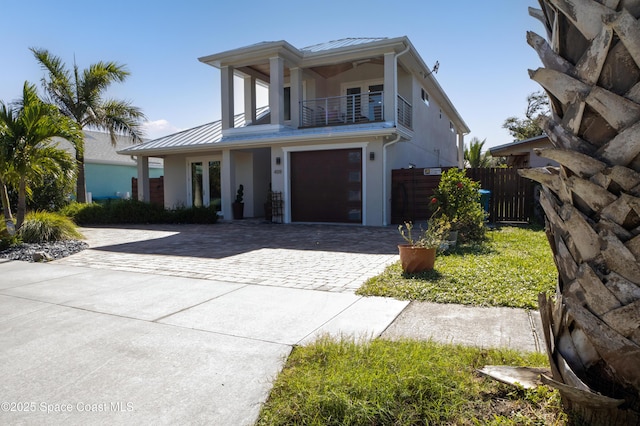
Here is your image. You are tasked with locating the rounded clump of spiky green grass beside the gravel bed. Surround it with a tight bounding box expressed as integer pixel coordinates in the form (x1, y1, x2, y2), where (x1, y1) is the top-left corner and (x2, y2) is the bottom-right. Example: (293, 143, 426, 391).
(18, 211, 82, 243)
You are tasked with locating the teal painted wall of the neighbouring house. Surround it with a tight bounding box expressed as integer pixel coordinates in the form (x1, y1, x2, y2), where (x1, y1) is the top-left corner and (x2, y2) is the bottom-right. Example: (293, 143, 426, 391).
(85, 164, 163, 200)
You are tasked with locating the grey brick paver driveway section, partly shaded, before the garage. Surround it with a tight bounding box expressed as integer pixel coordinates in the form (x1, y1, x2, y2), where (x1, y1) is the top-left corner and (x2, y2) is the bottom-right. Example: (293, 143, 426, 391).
(56, 220, 401, 292)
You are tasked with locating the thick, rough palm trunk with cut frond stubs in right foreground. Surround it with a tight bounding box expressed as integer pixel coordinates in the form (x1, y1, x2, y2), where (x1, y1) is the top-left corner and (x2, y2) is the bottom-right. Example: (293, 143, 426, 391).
(521, 0, 640, 425)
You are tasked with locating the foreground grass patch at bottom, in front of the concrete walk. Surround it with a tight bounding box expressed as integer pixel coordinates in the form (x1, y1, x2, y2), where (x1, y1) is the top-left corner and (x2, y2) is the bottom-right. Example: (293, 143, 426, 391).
(257, 338, 564, 425)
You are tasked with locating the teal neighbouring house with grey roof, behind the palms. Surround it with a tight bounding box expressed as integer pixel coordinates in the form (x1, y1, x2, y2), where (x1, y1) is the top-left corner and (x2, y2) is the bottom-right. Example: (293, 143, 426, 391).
(57, 130, 163, 200)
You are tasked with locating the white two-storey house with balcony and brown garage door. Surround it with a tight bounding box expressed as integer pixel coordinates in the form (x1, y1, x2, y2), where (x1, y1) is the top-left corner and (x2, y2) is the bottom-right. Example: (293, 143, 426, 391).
(119, 37, 469, 225)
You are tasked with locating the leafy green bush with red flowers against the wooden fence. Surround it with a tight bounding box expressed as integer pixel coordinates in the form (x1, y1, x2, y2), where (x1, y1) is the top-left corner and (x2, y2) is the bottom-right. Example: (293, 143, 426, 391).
(431, 168, 486, 243)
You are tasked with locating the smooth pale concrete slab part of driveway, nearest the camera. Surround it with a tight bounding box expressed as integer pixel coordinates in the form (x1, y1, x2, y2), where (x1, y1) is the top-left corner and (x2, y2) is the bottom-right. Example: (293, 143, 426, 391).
(0, 261, 407, 425)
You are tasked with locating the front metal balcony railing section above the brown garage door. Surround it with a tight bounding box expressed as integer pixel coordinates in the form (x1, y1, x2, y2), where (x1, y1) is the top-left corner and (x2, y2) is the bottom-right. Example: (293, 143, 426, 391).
(300, 92, 384, 127)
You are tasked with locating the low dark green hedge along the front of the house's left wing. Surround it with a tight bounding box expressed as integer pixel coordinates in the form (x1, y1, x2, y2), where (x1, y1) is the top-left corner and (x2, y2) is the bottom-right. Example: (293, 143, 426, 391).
(60, 200, 218, 225)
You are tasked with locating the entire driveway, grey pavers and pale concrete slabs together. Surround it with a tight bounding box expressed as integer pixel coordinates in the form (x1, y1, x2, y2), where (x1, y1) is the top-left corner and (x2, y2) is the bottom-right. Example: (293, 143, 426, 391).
(0, 221, 407, 425)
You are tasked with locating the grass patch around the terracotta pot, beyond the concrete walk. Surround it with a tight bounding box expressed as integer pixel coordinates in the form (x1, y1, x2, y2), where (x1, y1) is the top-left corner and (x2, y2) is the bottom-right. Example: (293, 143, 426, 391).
(357, 226, 557, 309)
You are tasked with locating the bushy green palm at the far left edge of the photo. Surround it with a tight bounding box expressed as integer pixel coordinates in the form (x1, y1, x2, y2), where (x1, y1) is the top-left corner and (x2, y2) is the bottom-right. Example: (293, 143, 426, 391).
(0, 82, 80, 229)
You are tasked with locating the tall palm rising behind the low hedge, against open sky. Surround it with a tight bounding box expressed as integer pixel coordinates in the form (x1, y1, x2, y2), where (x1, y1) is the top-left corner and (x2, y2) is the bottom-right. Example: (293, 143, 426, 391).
(31, 48, 145, 202)
